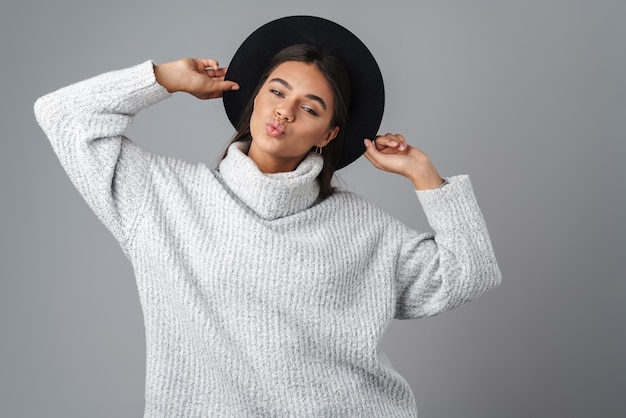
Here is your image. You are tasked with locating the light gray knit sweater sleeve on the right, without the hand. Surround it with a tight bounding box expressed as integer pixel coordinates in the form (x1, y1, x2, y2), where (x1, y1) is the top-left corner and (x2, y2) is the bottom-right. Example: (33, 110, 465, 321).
(395, 176, 501, 319)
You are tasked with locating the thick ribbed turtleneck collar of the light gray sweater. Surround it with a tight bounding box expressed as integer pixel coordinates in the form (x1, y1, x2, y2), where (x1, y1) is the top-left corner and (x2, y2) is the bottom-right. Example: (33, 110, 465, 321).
(219, 142, 324, 220)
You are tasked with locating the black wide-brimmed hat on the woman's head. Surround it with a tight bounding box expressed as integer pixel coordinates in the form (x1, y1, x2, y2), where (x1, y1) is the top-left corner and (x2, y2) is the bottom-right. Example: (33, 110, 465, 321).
(224, 16, 385, 169)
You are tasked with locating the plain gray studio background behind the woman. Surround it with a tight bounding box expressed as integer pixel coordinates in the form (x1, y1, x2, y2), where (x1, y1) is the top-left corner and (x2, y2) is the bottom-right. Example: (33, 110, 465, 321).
(0, 0, 626, 418)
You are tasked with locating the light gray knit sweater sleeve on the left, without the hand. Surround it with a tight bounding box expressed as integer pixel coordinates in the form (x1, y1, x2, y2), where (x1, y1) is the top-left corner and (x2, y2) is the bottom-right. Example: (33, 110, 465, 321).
(35, 61, 169, 248)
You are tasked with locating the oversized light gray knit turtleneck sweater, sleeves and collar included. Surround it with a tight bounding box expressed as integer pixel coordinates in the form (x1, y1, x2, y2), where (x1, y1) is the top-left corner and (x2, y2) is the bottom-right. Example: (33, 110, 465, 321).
(35, 62, 500, 417)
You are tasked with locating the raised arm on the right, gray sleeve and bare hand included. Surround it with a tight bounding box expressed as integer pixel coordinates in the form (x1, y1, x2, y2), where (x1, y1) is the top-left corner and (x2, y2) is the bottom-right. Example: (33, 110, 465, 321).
(365, 134, 501, 319)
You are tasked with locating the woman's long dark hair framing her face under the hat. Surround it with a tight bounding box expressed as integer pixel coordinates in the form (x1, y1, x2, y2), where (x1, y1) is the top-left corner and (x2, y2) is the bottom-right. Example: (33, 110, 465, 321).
(222, 44, 351, 200)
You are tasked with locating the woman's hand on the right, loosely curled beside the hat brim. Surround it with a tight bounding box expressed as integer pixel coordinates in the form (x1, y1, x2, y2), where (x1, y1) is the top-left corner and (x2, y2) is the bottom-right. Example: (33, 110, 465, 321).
(364, 134, 443, 190)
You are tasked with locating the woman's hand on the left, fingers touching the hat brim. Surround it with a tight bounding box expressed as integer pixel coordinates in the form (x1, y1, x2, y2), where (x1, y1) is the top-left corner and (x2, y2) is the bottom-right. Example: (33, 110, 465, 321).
(154, 58, 239, 99)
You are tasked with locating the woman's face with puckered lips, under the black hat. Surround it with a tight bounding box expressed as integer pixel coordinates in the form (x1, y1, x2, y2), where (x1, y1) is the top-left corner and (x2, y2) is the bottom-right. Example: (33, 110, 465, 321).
(248, 61, 339, 173)
